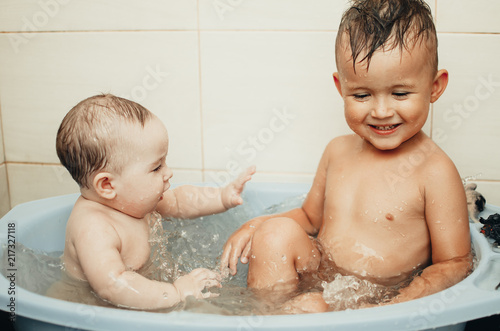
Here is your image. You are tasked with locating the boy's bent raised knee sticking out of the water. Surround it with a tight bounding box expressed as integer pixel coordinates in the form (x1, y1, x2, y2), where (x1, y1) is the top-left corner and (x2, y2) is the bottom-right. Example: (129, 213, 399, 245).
(247, 217, 320, 290)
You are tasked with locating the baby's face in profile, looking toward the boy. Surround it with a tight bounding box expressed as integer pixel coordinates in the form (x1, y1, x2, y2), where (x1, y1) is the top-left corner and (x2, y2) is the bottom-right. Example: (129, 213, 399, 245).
(116, 117, 172, 218)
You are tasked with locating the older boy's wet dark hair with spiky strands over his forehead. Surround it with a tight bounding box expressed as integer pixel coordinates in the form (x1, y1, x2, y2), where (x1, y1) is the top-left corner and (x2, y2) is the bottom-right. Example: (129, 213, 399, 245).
(336, 0, 438, 72)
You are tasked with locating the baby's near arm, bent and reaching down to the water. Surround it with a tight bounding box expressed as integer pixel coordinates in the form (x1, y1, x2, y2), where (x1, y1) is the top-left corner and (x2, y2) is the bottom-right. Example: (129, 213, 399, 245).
(74, 221, 220, 309)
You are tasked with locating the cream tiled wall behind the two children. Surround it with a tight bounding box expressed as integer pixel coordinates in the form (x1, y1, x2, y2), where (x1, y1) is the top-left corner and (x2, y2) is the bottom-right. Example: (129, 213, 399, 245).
(0, 0, 500, 218)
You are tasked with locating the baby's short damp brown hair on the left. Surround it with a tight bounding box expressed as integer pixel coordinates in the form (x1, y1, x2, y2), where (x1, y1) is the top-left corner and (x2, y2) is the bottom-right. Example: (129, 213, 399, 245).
(56, 94, 153, 188)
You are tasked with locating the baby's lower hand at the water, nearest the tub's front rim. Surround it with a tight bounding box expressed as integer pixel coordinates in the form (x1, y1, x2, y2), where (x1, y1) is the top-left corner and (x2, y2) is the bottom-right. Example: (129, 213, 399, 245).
(174, 268, 222, 301)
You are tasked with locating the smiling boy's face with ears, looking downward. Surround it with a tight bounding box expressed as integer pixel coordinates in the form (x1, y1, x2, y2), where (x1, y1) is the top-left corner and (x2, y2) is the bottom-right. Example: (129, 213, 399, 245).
(334, 37, 448, 150)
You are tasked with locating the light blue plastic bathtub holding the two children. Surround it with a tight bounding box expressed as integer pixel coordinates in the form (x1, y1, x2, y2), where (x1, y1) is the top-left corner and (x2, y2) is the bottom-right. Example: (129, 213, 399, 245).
(0, 183, 500, 331)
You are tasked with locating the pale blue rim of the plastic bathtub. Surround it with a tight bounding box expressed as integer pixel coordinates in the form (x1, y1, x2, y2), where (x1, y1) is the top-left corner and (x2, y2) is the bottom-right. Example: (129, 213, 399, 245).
(0, 183, 500, 330)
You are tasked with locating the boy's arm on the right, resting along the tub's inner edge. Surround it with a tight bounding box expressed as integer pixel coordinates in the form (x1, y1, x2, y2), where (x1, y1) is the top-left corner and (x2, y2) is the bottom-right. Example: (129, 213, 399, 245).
(393, 158, 472, 302)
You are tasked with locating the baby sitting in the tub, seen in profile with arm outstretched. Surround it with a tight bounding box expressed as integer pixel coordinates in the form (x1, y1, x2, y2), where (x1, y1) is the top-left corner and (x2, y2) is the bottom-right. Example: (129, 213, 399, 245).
(52, 95, 255, 309)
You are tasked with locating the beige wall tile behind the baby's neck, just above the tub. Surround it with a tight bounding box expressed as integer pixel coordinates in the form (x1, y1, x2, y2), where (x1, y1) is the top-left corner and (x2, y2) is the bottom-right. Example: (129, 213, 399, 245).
(7, 163, 79, 207)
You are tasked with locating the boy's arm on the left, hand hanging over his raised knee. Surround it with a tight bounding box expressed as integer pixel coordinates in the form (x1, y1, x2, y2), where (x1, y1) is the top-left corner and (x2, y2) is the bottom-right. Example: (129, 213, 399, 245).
(221, 142, 333, 275)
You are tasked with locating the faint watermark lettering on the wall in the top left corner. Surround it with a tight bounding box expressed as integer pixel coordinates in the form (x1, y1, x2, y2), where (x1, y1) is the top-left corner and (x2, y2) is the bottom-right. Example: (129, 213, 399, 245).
(7, 0, 71, 54)
